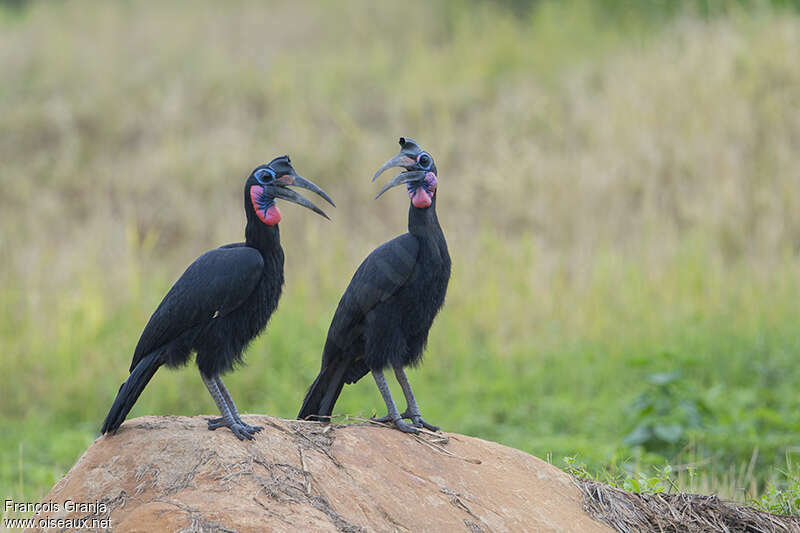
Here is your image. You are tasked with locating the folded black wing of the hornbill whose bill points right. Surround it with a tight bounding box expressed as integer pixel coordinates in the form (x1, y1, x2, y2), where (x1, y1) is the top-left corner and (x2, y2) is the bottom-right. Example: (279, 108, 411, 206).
(130, 244, 264, 371)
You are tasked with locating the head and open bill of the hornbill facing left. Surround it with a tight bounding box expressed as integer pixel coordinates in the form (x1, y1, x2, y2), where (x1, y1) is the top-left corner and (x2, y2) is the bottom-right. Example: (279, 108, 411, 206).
(372, 137, 438, 209)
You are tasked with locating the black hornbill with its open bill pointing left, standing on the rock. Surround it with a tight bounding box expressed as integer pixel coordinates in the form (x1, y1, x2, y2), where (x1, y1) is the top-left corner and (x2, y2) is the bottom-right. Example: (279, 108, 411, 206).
(298, 137, 450, 433)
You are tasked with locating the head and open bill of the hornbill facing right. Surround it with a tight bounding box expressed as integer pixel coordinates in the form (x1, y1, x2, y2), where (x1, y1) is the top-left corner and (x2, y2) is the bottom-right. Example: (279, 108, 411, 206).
(245, 155, 336, 226)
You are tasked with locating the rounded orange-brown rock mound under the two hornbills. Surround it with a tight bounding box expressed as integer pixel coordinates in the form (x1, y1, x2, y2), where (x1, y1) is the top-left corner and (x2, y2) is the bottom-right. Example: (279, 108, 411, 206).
(28, 415, 612, 533)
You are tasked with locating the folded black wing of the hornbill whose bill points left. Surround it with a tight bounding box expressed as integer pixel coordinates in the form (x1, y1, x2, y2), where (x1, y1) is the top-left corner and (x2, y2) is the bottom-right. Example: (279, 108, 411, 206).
(323, 233, 419, 365)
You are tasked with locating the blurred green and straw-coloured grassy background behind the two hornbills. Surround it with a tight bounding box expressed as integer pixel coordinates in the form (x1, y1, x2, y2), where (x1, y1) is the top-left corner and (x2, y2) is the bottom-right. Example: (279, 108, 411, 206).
(0, 0, 800, 512)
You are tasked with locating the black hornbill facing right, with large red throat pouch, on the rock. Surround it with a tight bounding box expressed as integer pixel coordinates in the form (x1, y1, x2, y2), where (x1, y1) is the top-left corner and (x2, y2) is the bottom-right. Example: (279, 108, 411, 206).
(102, 156, 333, 440)
